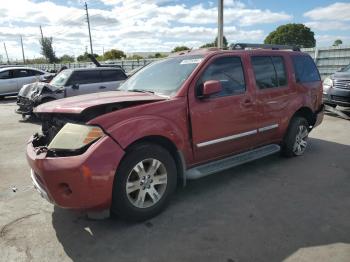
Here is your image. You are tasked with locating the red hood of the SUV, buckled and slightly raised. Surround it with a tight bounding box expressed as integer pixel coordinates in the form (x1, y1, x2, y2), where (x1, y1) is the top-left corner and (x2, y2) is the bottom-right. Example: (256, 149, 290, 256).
(34, 91, 167, 114)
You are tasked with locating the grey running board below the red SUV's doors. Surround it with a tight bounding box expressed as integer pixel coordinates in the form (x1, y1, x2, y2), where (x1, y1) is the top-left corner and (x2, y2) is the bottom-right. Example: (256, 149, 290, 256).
(185, 144, 281, 179)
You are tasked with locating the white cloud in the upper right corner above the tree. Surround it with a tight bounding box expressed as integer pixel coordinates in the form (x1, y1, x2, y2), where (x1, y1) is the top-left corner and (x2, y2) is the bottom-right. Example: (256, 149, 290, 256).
(304, 2, 350, 21)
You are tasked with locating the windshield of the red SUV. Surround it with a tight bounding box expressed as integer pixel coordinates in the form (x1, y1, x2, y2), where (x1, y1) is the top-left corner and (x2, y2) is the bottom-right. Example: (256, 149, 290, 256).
(119, 55, 203, 96)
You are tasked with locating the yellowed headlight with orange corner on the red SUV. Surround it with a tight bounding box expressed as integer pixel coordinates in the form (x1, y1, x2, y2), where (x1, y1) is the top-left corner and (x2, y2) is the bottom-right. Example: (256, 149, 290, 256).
(48, 123, 104, 150)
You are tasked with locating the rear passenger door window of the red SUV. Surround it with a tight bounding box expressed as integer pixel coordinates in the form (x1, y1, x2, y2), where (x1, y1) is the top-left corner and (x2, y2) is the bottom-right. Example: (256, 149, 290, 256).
(252, 56, 287, 89)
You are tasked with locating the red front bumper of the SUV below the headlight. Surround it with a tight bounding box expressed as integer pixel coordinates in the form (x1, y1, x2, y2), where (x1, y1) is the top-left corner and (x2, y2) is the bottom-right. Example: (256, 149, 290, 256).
(26, 124, 124, 211)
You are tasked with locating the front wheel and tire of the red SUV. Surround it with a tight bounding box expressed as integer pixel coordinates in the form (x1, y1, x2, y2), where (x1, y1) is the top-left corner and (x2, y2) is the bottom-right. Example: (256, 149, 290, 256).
(111, 143, 177, 221)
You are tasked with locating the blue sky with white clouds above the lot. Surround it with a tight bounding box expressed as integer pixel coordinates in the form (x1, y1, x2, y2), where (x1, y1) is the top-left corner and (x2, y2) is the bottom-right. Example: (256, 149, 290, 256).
(0, 0, 350, 60)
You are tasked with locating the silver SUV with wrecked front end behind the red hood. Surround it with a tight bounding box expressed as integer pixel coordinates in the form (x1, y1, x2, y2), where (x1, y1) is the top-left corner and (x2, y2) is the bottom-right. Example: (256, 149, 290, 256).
(16, 67, 127, 116)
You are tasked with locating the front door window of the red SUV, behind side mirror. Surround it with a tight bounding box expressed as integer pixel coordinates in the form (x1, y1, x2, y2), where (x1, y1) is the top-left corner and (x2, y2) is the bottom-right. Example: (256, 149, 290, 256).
(196, 57, 246, 97)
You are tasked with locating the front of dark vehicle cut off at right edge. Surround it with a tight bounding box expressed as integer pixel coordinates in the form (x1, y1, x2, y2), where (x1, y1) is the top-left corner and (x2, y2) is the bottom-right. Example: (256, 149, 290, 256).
(323, 64, 350, 107)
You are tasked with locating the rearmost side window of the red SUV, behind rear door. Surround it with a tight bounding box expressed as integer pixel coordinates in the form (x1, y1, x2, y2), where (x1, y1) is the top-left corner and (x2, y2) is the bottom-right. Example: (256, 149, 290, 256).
(292, 56, 321, 83)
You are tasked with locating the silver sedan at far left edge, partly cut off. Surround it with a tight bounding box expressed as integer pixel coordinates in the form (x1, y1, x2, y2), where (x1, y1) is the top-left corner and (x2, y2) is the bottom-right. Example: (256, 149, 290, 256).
(0, 67, 51, 98)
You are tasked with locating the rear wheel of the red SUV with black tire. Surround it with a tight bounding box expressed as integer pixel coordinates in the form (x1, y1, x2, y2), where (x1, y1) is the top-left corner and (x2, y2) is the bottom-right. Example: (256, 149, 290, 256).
(281, 116, 309, 157)
